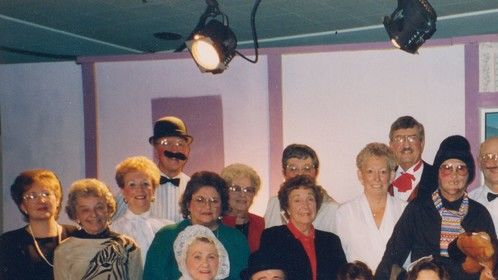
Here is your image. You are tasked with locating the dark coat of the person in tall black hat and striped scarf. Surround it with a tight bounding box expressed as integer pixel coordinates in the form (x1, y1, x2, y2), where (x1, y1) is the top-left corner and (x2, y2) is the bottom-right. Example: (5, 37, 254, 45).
(375, 192, 496, 280)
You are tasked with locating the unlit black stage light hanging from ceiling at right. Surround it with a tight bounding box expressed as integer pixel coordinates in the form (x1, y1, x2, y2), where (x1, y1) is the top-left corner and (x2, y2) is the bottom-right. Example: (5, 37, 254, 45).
(384, 0, 437, 54)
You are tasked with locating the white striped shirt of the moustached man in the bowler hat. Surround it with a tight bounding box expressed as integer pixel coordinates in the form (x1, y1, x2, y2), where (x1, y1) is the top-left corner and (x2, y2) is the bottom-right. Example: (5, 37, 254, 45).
(113, 172, 190, 223)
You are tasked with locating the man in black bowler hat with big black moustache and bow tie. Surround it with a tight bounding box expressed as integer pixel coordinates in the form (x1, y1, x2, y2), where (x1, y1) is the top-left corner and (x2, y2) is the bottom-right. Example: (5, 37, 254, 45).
(114, 116, 193, 222)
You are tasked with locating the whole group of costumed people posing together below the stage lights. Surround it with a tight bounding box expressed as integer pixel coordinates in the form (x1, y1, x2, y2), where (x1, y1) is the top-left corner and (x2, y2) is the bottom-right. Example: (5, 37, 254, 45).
(0, 116, 498, 280)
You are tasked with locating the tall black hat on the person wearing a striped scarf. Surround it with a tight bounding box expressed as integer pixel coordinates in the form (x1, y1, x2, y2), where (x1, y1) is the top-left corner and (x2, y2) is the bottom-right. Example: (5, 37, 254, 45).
(433, 135, 476, 184)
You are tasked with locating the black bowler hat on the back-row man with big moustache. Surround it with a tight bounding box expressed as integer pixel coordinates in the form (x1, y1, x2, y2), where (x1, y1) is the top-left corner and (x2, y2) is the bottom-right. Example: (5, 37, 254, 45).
(149, 116, 194, 144)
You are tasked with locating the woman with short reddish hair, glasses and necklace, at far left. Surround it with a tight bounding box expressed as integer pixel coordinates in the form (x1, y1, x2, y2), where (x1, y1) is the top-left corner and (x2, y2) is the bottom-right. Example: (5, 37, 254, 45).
(0, 169, 76, 280)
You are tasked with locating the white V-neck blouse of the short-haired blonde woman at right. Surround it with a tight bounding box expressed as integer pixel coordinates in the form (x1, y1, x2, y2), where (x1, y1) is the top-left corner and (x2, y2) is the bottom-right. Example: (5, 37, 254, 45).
(336, 193, 407, 271)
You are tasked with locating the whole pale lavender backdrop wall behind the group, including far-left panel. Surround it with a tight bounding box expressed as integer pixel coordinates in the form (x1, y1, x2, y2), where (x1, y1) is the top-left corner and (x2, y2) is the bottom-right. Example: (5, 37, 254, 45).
(0, 41, 468, 230)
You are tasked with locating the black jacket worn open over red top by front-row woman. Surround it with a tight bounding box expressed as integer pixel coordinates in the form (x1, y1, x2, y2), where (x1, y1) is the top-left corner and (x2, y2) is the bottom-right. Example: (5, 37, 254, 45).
(260, 225, 346, 280)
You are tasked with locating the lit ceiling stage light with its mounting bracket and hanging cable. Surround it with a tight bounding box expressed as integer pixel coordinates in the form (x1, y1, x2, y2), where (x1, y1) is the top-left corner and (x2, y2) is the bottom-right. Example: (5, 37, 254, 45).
(185, 0, 261, 74)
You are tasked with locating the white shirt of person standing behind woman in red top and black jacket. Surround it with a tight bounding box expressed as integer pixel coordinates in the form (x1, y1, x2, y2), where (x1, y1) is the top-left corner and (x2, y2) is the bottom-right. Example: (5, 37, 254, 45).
(265, 196, 339, 234)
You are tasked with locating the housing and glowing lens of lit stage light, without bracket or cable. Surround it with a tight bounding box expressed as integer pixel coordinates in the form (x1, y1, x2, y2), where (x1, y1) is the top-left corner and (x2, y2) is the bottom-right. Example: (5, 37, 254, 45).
(185, 19, 237, 74)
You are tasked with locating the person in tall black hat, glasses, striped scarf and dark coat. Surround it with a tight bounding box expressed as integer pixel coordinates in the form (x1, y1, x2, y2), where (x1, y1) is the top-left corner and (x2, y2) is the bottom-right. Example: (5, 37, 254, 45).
(375, 135, 496, 279)
